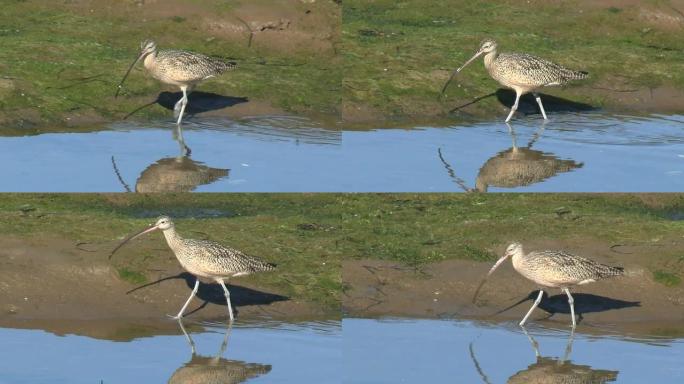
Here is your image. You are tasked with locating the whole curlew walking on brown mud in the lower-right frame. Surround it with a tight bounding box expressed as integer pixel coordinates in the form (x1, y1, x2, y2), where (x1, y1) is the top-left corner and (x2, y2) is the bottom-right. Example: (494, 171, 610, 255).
(473, 243, 624, 329)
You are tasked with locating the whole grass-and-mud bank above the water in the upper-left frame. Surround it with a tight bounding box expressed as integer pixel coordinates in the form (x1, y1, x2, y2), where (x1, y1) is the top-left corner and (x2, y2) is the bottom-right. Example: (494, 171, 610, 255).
(0, 0, 341, 129)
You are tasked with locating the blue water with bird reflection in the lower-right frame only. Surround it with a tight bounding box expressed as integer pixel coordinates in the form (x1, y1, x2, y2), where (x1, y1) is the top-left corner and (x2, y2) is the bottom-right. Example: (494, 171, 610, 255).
(342, 319, 684, 383)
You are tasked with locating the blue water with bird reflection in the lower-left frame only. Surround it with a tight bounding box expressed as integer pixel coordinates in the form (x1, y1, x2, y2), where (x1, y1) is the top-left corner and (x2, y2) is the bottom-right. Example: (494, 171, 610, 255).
(0, 320, 342, 384)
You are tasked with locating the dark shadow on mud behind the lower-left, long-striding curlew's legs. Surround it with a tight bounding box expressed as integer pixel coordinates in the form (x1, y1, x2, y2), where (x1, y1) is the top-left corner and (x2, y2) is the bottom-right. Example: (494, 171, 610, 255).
(126, 272, 290, 315)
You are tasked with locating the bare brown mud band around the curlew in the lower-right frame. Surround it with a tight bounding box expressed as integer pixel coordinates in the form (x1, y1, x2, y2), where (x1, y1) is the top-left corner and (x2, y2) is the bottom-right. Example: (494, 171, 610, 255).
(343, 241, 684, 336)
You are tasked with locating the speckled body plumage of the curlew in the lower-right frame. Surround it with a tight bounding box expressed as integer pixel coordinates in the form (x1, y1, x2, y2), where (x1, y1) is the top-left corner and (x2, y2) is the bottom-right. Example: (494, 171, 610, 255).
(514, 251, 624, 287)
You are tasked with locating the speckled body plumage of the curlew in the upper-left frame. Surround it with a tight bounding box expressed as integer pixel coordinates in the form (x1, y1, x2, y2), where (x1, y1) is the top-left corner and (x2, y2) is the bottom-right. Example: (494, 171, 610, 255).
(153, 50, 237, 83)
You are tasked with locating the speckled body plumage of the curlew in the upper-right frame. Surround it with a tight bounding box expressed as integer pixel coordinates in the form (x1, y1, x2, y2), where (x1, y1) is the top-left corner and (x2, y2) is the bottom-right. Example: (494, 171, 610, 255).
(487, 53, 587, 88)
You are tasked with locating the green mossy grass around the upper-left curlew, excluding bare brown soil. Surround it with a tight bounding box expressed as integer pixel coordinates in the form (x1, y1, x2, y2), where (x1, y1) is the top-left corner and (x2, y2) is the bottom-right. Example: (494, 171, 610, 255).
(0, 1, 341, 125)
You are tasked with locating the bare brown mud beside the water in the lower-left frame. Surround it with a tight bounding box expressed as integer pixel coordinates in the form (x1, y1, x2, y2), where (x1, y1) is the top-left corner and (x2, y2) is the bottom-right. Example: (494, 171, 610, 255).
(0, 236, 339, 333)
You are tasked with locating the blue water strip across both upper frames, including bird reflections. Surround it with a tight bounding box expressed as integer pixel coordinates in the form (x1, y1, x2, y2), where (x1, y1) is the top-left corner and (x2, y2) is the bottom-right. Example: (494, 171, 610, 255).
(0, 112, 684, 192)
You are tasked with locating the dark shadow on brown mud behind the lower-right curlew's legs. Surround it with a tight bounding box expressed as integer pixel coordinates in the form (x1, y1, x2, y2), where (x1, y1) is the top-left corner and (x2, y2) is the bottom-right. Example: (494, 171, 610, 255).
(498, 290, 641, 319)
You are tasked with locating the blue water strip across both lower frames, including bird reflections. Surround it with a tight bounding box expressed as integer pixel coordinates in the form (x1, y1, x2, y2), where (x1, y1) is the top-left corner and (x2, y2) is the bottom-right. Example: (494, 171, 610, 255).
(0, 318, 684, 384)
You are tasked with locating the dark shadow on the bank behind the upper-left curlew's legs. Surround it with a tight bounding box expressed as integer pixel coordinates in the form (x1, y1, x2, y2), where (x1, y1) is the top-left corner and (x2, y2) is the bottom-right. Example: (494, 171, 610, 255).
(124, 91, 249, 120)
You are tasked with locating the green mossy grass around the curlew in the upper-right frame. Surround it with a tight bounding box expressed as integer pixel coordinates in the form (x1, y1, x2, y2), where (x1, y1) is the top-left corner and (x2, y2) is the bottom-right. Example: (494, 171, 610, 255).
(342, 0, 684, 117)
